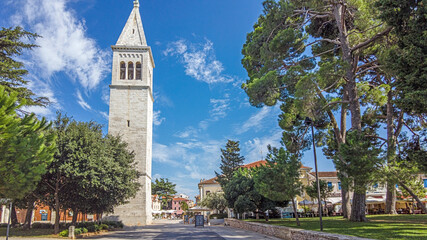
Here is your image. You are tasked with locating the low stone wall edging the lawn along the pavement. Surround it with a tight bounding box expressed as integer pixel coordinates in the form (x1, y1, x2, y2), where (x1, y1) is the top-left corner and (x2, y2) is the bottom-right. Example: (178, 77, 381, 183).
(225, 218, 367, 240)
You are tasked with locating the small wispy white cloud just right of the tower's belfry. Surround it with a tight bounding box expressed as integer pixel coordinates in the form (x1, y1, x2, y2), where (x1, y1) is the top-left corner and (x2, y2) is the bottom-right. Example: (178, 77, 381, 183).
(163, 40, 233, 84)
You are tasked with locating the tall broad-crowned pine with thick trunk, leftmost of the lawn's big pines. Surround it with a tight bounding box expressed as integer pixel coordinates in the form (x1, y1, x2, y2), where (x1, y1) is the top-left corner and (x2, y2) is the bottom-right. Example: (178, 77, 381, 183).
(242, 0, 392, 221)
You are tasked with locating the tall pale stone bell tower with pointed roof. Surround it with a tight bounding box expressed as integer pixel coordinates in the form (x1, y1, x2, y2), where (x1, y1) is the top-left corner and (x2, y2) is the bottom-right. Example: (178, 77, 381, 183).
(107, 0, 154, 226)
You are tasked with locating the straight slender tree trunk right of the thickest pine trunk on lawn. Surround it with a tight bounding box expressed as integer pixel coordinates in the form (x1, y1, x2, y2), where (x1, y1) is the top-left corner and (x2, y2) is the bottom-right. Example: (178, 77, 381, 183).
(385, 91, 397, 214)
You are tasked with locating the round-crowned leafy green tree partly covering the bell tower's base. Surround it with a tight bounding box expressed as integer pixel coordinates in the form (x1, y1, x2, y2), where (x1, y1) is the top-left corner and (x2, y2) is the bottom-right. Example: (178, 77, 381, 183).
(42, 113, 140, 232)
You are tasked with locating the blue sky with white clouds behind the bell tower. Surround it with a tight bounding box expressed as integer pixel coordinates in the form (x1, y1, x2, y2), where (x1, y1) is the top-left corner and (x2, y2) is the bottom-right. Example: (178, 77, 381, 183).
(0, 0, 333, 197)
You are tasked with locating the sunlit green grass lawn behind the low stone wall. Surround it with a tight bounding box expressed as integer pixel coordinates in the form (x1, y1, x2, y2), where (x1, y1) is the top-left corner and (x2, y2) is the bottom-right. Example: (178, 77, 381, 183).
(246, 214, 427, 240)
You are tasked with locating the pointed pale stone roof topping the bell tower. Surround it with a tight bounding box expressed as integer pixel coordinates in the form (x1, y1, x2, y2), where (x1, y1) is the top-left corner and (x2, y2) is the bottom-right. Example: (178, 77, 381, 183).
(116, 0, 147, 46)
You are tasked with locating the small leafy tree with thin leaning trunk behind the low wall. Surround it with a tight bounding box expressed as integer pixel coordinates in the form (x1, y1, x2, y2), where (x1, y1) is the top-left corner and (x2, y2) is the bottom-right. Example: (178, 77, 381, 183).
(255, 146, 302, 226)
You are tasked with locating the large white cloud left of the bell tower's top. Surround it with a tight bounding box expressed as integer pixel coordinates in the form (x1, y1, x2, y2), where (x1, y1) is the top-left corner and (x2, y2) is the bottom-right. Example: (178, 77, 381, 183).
(12, 0, 110, 89)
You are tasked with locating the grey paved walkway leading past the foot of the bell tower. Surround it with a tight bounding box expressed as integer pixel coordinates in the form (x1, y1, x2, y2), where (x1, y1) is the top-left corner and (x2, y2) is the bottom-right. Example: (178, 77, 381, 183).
(5, 220, 284, 240)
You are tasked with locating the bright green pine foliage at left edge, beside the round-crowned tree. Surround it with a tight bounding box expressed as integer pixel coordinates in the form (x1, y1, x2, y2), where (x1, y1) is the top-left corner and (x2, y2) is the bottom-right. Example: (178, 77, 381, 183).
(0, 86, 55, 200)
